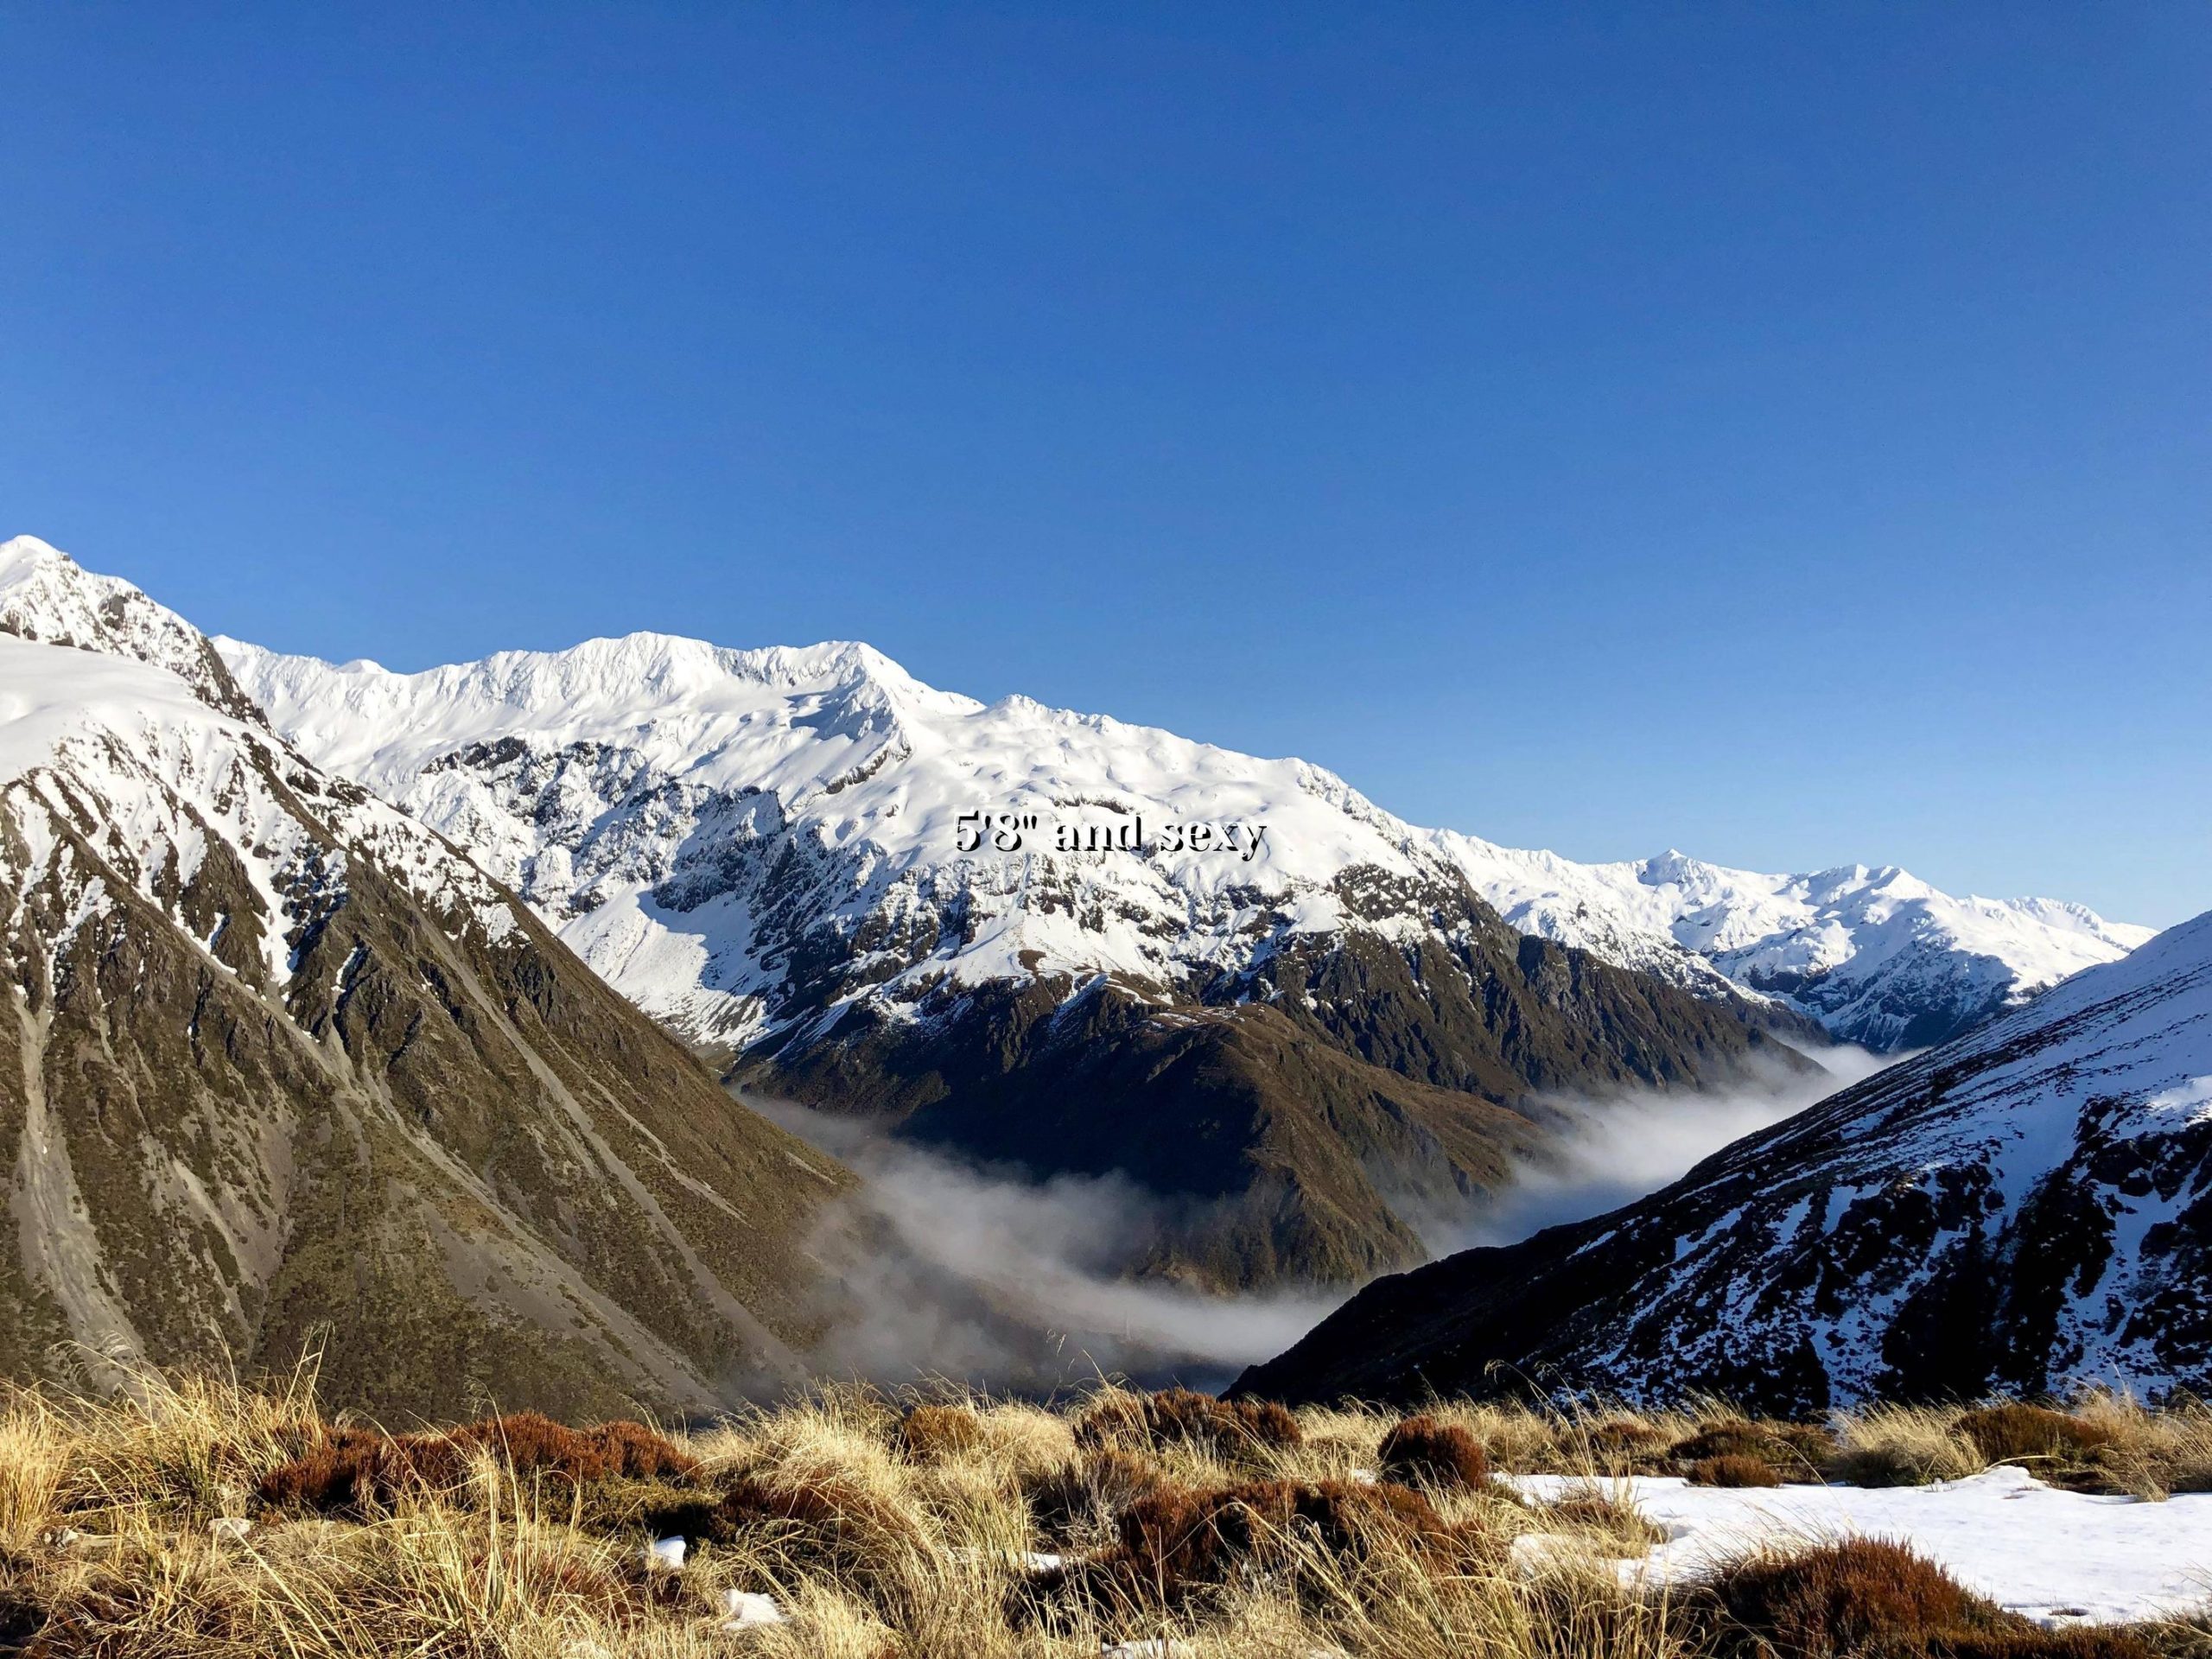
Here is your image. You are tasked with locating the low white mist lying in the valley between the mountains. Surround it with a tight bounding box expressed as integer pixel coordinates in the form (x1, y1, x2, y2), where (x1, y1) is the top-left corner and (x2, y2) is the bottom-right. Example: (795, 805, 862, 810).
(750, 1048, 1893, 1391)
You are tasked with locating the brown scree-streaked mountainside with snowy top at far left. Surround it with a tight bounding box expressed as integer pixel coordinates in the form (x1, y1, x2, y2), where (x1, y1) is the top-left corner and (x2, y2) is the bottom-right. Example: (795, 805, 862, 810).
(0, 542, 849, 1415)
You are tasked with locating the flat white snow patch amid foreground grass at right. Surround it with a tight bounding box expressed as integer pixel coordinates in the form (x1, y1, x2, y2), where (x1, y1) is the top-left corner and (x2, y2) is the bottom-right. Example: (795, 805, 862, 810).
(1504, 1466, 2212, 1626)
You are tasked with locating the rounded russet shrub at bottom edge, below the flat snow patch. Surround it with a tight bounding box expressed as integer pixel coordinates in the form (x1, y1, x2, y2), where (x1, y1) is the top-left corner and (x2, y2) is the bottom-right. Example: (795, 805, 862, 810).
(1710, 1537, 2004, 1659)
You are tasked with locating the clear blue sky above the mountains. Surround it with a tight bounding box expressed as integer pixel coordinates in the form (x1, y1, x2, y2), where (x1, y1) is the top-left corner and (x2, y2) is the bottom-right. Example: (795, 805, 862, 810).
(0, 0, 2212, 923)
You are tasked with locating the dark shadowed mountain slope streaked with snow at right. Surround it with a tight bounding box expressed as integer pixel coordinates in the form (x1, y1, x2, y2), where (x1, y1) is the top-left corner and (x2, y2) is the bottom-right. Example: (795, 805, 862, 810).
(1239, 913, 2212, 1411)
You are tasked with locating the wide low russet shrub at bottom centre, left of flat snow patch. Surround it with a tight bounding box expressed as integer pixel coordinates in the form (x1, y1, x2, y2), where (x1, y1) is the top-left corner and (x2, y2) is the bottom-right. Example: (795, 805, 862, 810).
(1071, 1480, 1478, 1604)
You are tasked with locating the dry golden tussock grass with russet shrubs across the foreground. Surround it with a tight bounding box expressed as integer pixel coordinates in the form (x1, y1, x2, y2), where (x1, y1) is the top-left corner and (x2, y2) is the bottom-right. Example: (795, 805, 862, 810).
(0, 1376, 2212, 1659)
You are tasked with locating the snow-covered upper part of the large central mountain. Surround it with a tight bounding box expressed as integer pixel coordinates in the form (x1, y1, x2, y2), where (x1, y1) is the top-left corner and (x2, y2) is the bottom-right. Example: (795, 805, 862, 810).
(219, 635, 1453, 1039)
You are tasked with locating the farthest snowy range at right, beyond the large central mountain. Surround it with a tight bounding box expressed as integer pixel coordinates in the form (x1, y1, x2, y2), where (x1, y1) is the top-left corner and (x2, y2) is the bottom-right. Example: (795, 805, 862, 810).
(1435, 830, 2152, 1053)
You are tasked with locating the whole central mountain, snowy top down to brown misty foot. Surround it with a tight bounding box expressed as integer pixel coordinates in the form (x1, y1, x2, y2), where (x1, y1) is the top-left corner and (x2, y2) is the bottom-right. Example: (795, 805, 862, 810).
(221, 606, 1812, 1287)
